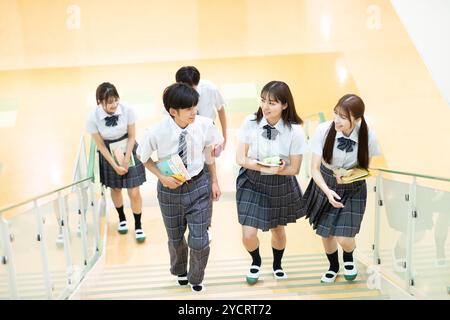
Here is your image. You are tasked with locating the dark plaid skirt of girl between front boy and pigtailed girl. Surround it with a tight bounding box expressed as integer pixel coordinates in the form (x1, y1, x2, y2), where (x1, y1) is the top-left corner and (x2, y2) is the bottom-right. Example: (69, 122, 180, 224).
(236, 168, 302, 231)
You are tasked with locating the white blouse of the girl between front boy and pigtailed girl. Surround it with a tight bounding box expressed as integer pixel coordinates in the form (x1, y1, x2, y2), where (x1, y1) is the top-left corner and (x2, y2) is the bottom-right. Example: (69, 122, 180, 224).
(238, 115, 307, 161)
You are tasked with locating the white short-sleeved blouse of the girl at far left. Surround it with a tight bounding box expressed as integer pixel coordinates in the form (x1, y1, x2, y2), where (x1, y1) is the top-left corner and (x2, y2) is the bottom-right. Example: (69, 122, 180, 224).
(86, 104, 136, 140)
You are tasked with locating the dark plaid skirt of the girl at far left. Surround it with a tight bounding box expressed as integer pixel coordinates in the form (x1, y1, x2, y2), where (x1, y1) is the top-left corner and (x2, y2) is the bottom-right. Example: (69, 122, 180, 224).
(98, 134, 146, 189)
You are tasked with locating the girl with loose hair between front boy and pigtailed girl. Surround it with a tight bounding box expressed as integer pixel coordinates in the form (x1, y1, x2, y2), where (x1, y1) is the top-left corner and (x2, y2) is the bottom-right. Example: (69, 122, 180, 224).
(236, 81, 307, 284)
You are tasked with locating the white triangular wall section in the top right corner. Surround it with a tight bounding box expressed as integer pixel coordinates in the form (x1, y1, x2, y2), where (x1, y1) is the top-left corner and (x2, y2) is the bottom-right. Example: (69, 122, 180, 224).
(391, 0, 450, 106)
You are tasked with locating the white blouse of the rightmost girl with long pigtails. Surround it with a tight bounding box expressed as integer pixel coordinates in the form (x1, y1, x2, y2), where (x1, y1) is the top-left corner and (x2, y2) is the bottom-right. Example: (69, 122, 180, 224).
(311, 120, 381, 169)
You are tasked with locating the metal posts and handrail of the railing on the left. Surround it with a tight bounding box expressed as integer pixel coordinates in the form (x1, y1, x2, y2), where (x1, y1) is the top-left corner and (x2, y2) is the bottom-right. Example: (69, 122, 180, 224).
(0, 137, 100, 299)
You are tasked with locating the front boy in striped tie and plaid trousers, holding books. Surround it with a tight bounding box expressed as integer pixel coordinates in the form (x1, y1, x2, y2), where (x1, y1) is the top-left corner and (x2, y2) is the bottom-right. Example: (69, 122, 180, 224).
(137, 83, 223, 292)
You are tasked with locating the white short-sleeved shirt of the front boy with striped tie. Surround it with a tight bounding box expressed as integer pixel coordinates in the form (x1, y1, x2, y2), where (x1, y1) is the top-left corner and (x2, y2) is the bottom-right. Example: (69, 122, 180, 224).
(136, 115, 224, 177)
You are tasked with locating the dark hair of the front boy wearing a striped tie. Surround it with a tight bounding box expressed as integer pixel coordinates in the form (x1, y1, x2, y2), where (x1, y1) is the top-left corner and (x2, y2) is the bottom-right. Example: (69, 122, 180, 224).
(163, 82, 199, 112)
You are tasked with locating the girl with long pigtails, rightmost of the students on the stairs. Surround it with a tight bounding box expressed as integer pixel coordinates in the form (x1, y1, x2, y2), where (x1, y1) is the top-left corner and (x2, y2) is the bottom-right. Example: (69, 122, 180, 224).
(302, 94, 380, 283)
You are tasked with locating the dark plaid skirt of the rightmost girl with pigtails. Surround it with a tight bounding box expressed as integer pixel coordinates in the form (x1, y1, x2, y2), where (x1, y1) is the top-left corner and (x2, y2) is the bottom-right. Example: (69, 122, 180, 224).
(301, 164, 367, 238)
